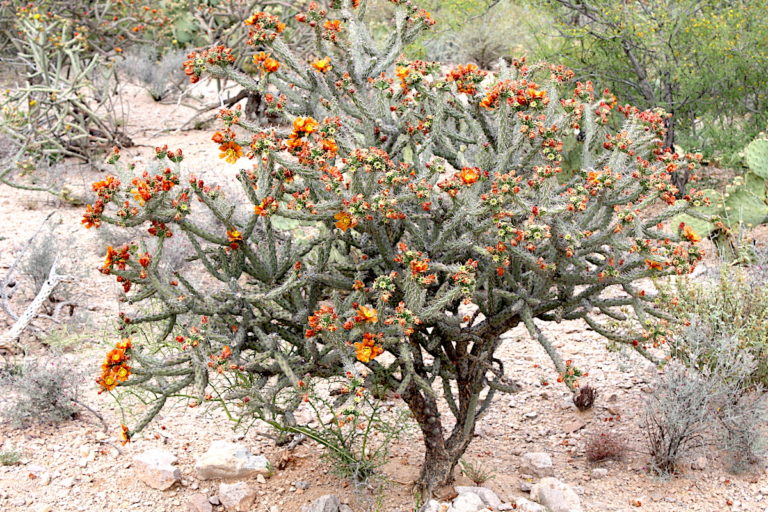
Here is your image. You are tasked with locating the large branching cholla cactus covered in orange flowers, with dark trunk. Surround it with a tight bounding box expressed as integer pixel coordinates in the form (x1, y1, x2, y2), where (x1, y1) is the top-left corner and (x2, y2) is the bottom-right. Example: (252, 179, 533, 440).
(84, 0, 701, 492)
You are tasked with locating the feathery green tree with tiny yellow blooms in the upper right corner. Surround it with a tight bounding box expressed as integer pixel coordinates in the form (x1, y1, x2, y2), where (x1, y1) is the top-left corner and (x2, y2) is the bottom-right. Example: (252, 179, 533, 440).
(540, 0, 768, 152)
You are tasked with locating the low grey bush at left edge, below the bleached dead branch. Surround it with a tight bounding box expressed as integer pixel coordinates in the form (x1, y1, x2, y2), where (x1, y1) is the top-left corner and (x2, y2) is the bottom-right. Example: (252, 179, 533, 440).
(0, 355, 82, 428)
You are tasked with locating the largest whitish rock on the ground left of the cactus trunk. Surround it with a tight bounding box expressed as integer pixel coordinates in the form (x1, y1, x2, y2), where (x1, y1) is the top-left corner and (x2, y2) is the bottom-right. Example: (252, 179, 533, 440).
(195, 441, 269, 480)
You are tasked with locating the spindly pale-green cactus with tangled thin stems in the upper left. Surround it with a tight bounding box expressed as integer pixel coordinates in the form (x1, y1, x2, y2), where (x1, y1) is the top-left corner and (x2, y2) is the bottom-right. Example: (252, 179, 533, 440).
(0, 1, 131, 184)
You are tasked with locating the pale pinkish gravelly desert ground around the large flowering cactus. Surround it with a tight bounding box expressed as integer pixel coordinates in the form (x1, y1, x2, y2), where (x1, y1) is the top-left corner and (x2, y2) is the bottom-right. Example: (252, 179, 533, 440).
(0, 80, 768, 512)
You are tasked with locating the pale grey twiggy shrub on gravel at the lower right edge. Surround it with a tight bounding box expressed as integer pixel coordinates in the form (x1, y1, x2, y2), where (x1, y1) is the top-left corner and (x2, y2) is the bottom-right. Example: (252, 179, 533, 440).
(645, 321, 768, 473)
